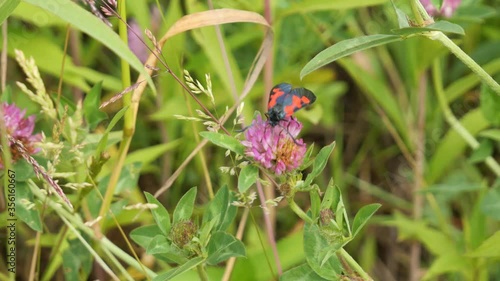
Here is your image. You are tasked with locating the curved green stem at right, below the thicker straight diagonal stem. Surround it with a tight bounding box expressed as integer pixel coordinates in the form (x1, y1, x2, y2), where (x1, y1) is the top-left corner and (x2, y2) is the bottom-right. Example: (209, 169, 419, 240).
(432, 59, 500, 177)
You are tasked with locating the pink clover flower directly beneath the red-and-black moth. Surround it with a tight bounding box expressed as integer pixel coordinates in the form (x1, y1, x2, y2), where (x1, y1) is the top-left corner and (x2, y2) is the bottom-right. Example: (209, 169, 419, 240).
(242, 115, 306, 175)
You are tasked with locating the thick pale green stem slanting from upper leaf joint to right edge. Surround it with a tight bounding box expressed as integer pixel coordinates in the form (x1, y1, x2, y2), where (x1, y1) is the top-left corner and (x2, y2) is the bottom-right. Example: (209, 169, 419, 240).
(428, 31, 500, 95)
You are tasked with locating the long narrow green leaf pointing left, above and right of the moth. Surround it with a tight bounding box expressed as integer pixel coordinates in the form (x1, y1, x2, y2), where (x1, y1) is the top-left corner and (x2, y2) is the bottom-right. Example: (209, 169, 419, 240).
(300, 34, 402, 79)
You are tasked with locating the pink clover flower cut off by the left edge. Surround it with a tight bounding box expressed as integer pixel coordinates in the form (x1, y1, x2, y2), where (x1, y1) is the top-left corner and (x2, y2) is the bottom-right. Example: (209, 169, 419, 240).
(0, 103, 42, 168)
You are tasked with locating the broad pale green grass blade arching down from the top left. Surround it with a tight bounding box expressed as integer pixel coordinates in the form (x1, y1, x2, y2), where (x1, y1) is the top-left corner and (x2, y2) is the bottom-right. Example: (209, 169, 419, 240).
(24, 0, 156, 92)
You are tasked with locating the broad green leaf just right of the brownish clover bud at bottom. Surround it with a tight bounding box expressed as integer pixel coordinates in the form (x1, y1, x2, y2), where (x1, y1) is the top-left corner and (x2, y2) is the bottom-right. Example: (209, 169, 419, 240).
(207, 231, 246, 265)
